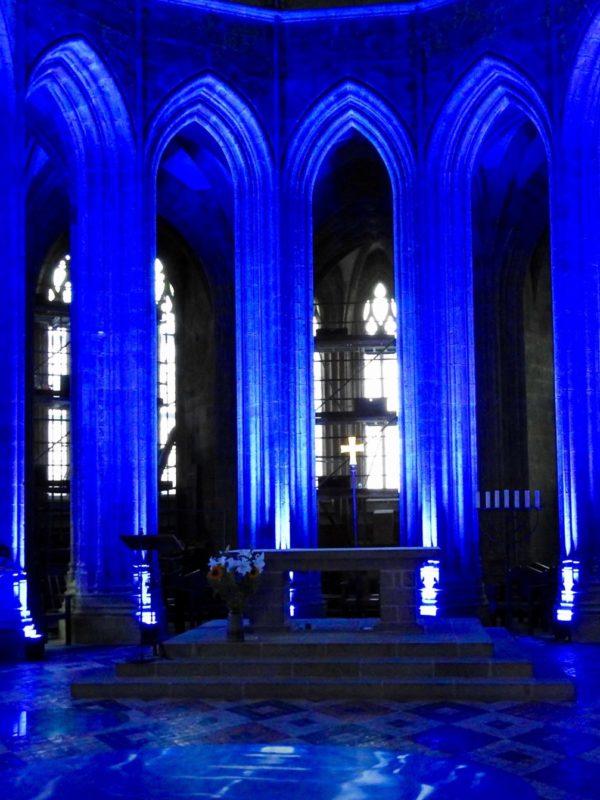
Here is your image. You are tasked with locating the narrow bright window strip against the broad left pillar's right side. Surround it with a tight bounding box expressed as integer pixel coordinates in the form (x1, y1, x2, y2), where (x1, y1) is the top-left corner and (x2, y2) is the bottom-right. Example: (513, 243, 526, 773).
(154, 258, 177, 495)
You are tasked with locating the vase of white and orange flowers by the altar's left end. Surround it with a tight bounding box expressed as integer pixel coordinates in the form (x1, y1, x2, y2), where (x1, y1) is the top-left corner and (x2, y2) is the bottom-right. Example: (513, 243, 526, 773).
(207, 548, 265, 641)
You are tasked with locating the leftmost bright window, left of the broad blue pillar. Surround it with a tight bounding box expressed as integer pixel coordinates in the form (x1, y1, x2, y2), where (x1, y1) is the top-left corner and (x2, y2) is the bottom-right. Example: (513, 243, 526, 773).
(34, 255, 71, 497)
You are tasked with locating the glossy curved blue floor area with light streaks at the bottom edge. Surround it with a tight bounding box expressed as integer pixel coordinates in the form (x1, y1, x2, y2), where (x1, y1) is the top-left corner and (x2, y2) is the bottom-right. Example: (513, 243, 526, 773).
(2, 744, 536, 800)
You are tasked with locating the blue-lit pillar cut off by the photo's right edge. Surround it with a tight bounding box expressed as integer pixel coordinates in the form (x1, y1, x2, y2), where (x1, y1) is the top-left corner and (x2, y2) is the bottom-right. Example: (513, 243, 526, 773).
(551, 53, 600, 642)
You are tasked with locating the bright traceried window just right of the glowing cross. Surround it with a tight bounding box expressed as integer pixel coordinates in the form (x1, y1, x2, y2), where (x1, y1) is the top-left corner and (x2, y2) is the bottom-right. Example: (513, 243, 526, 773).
(363, 282, 400, 490)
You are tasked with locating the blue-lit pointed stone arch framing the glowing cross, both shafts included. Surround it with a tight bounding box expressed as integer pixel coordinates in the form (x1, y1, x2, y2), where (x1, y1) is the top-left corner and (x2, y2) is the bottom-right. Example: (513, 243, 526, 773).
(282, 80, 420, 546)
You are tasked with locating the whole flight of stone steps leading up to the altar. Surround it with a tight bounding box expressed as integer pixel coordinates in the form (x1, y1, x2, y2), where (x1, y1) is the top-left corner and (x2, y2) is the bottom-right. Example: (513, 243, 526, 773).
(71, 620, 574, 701)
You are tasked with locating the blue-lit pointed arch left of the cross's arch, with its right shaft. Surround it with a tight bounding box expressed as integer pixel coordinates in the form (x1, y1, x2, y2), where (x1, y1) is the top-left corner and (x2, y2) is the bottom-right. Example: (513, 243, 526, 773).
(146, 74, 278, 547)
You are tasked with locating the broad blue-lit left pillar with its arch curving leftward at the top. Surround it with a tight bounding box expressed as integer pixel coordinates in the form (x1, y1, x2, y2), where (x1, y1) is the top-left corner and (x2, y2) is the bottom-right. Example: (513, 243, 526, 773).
(27, 39, 150, 643)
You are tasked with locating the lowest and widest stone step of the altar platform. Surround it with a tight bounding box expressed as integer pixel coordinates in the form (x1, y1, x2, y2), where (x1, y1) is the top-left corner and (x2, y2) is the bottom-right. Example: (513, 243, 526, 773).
(71, 673, 574, 702)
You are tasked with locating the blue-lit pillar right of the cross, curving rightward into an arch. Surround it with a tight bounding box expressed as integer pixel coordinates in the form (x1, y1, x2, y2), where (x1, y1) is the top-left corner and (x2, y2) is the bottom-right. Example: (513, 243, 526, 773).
(420, 60, 501, 615)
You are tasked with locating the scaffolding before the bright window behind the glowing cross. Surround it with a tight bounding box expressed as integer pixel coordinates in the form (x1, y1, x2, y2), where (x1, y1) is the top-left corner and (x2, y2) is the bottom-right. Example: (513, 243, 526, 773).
(314, 296, 400, 546)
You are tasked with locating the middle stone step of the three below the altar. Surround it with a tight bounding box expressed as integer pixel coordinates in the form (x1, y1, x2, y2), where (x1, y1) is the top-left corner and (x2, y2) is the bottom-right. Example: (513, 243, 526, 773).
(117, 653, 532, 679)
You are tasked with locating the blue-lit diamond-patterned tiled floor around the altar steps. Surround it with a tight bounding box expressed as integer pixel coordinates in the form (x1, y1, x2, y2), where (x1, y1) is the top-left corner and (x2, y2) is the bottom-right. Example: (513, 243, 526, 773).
(0, 639, 600, 800)
